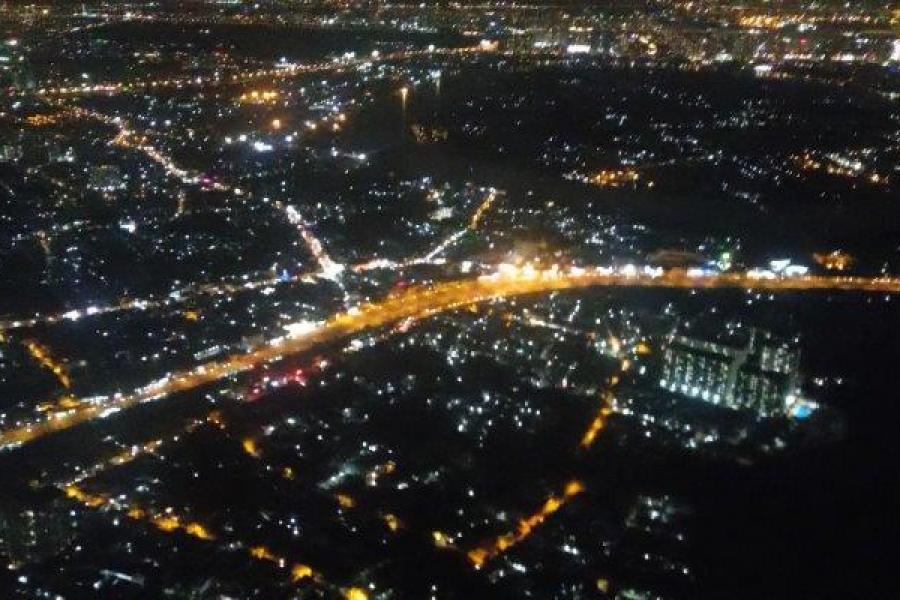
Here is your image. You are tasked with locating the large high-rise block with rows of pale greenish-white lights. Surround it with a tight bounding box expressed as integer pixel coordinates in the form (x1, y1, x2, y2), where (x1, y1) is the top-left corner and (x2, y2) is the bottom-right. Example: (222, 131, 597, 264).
(659, 326, 800, 416)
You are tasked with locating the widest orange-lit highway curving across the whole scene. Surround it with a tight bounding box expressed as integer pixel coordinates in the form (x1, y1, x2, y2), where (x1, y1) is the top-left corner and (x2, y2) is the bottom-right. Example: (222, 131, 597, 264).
(0, 265, 900, 449)
